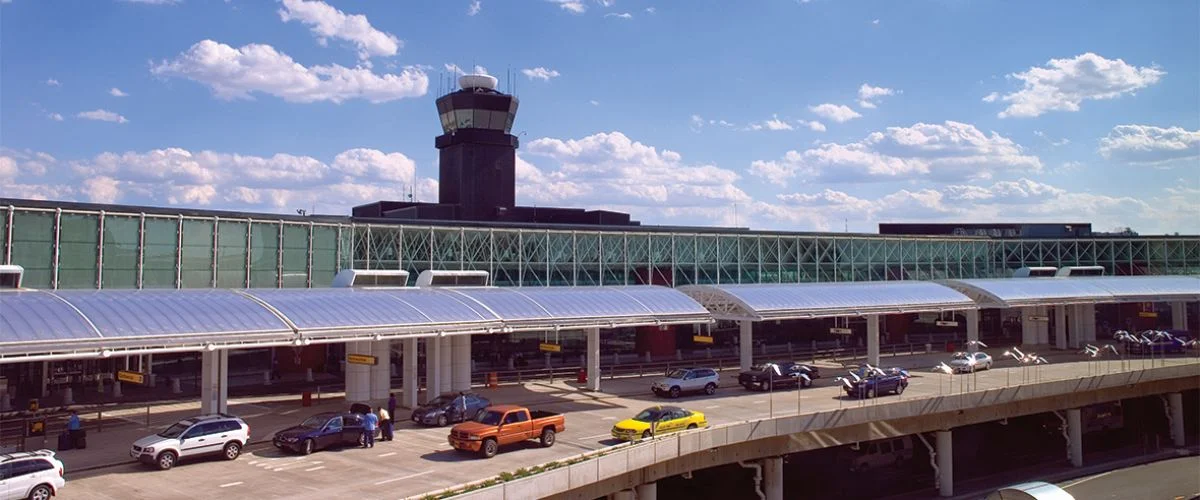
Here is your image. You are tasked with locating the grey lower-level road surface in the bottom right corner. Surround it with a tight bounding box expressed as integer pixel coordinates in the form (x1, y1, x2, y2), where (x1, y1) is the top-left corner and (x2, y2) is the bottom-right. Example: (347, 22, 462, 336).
(1058, 457, 1200, 500)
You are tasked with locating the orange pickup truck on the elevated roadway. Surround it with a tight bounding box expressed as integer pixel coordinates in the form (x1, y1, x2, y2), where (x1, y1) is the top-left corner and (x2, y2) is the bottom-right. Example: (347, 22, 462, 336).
(448, 405, 566, 458)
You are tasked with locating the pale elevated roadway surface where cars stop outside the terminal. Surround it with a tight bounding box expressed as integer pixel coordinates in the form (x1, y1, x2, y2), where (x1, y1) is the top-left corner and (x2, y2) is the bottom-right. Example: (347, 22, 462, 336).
(59, 354, 1200, 500)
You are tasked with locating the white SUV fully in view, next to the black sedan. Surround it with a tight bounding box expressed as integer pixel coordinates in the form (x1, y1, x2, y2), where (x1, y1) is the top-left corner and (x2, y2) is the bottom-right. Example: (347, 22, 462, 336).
(130, 414, 250, 470)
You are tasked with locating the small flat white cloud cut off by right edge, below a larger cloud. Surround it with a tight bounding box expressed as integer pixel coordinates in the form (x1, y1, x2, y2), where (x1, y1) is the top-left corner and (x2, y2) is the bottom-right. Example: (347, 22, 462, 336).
(1099, 125, 1200, 167)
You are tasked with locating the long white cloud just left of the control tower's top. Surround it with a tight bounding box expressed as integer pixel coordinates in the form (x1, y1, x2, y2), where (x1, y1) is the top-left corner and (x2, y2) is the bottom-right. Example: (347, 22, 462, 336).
(150, 40, 430, 103)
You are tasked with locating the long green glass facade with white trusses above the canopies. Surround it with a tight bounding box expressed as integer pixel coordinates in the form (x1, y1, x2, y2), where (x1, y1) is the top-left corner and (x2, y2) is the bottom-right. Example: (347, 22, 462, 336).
(0, 202, 1200, 289)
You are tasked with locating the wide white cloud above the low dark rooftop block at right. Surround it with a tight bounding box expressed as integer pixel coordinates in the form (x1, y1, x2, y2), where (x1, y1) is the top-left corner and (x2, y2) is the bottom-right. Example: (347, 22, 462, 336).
(750, 121, 1042, 186)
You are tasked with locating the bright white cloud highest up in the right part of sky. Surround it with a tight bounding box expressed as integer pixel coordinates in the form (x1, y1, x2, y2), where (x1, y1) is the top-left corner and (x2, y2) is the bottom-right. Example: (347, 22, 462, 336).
(984, 53, 1166, 118)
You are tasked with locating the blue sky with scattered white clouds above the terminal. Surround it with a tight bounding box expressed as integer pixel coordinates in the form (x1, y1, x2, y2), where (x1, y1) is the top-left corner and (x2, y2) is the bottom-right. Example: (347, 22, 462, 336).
(0, 0, 1200, 234)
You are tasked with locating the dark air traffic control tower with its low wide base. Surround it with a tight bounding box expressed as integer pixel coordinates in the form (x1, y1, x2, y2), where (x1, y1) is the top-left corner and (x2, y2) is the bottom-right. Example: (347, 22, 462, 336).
(353, 74, 637, 225)
